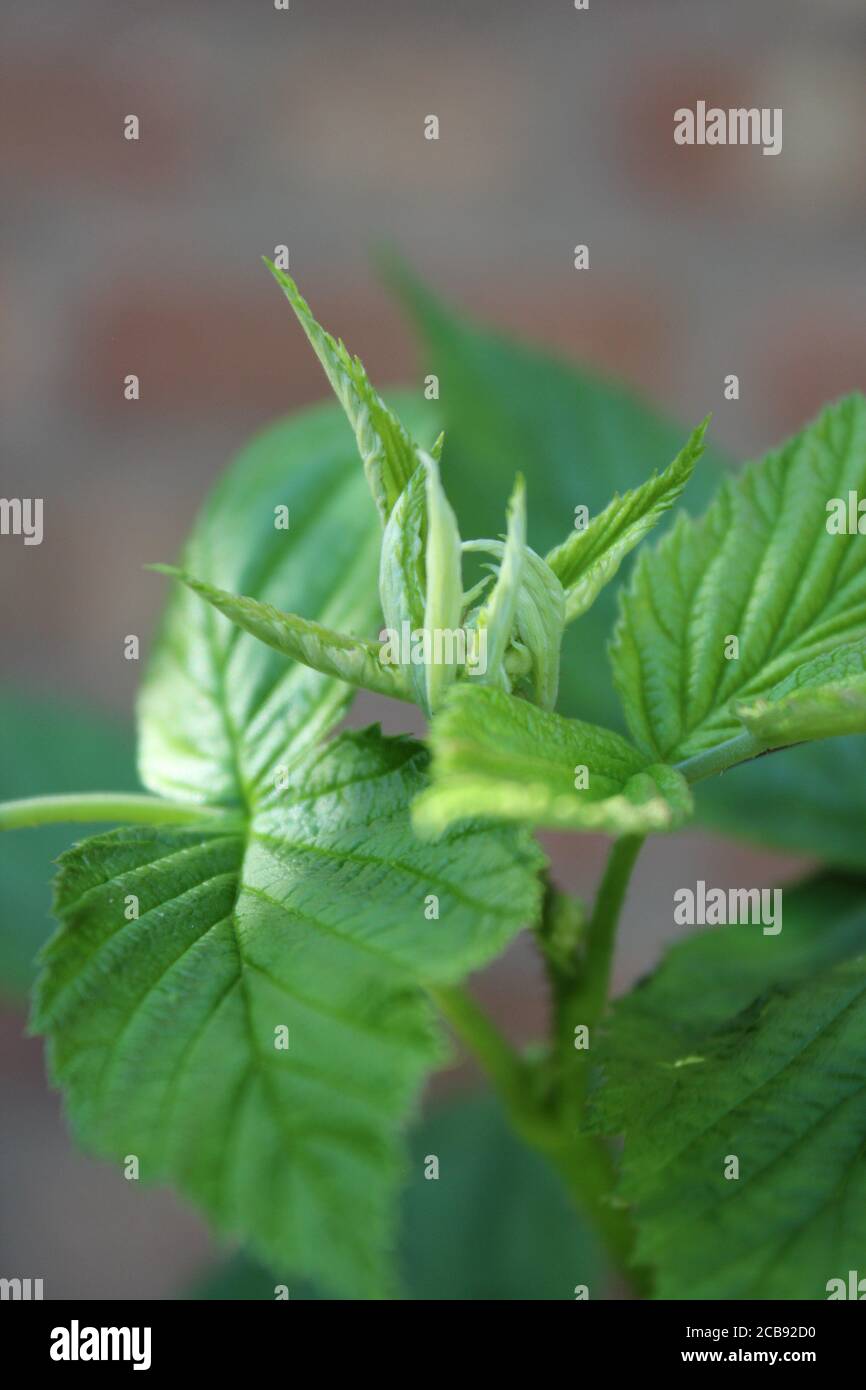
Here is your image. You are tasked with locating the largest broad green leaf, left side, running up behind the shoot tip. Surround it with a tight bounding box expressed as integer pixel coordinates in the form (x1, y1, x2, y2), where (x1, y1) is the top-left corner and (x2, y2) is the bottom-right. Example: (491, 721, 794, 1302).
(36, 394, 542, 1297)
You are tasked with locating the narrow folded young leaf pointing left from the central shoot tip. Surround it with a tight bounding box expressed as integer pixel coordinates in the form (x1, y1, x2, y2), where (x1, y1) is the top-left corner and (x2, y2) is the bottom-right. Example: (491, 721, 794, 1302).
(150, 564, 411, 701)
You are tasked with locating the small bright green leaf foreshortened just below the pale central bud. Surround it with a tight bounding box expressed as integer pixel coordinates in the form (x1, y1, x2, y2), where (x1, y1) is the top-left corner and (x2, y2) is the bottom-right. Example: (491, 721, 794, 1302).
(413, 684, 691, 835)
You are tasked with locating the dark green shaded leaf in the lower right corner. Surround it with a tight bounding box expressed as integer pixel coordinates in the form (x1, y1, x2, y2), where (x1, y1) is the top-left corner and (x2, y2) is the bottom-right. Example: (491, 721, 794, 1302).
(596, 878, 866, 1298)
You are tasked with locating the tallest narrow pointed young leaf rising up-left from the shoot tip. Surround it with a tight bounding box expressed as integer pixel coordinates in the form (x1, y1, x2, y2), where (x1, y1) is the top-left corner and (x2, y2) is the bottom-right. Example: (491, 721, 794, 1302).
(265, 257, 418, 524)
